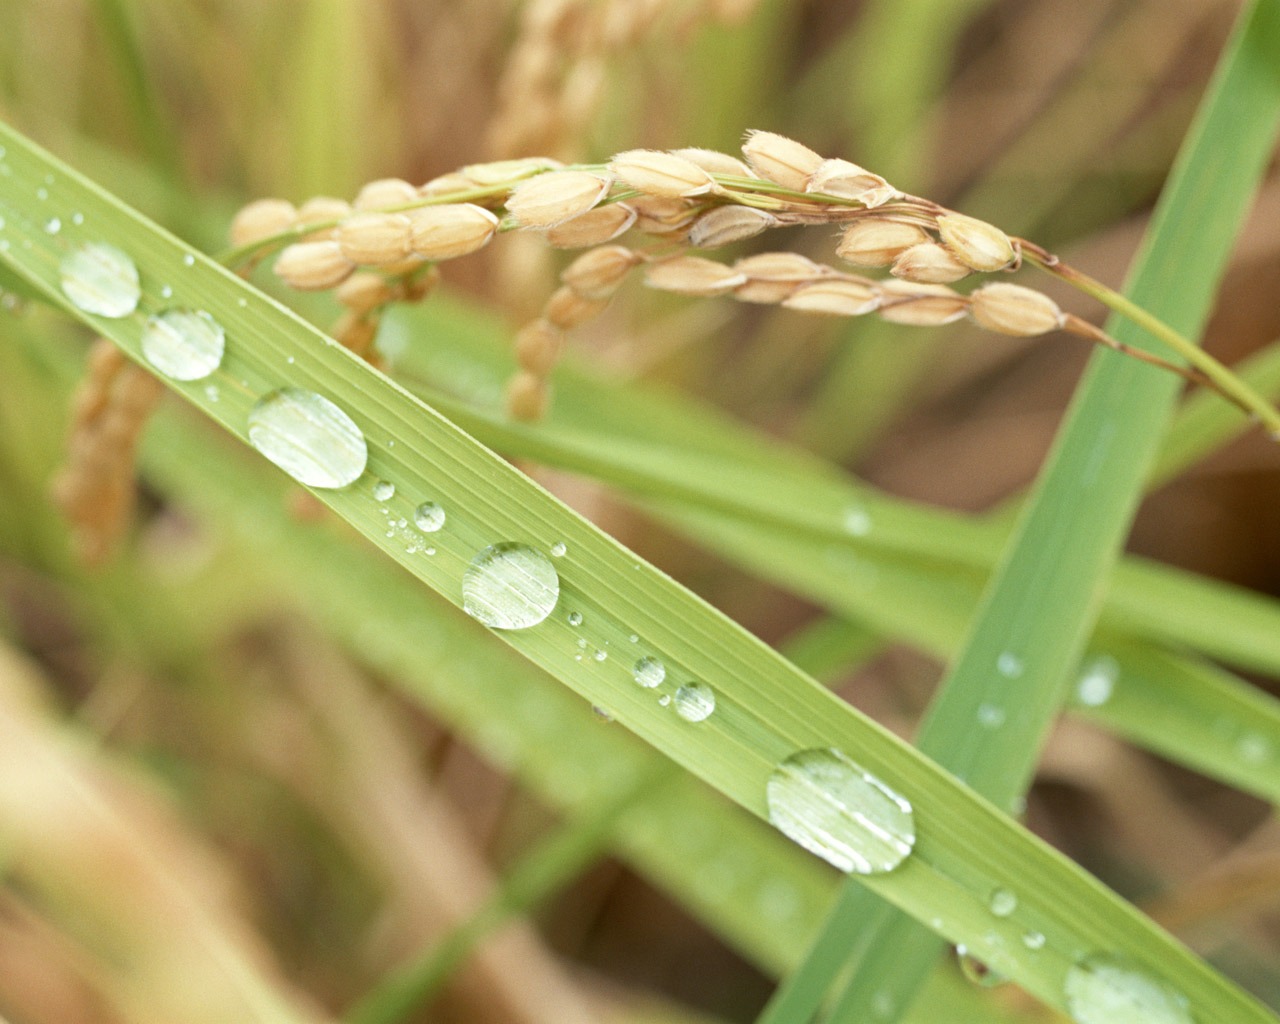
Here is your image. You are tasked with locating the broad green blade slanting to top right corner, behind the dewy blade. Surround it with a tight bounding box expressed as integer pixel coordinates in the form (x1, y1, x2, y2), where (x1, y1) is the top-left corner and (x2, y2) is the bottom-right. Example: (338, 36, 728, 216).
(803, 0, 1280, 1021)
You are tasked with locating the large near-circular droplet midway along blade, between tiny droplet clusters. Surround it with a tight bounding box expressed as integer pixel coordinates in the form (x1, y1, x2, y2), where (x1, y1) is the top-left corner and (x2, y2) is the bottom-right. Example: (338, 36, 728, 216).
(462, 541, 559, 630)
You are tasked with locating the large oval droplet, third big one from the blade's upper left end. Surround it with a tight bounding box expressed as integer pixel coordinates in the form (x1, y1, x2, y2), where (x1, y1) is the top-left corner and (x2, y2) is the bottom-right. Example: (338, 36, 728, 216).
(248, 388, 369, 488)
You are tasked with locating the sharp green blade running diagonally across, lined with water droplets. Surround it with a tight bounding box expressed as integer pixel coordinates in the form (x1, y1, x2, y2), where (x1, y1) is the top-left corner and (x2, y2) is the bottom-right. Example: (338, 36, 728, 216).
(0, 120, 1270, 1024)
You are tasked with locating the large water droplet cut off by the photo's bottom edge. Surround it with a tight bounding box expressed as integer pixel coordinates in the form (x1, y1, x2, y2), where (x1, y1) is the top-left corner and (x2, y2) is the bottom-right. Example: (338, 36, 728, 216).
(1064, 956, 1192, 1024)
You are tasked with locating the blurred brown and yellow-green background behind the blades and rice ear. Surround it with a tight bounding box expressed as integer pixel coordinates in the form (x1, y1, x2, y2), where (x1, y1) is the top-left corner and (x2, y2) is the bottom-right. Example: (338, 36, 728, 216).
(0, 0, 1280, 1021)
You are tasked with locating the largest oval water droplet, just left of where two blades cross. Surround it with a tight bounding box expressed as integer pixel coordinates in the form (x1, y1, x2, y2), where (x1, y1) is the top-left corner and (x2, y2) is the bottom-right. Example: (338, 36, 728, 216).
(765, 749, 915, 874)
